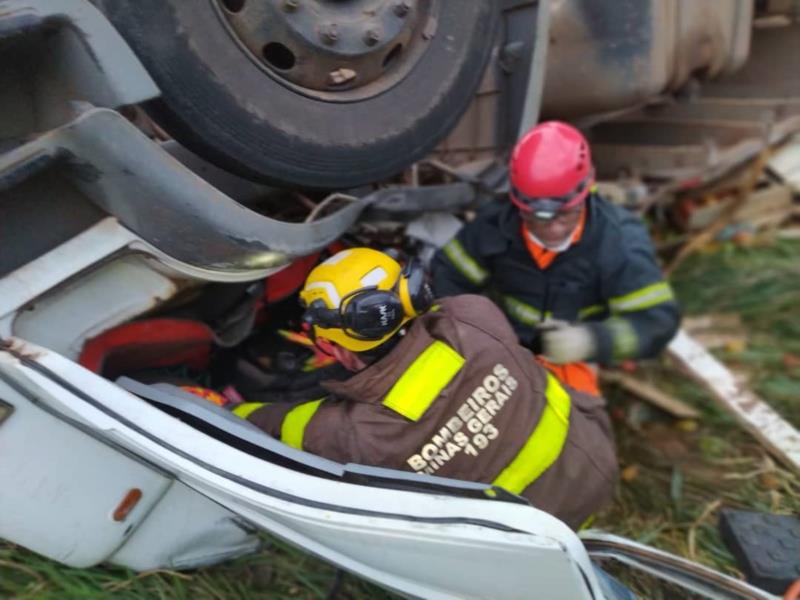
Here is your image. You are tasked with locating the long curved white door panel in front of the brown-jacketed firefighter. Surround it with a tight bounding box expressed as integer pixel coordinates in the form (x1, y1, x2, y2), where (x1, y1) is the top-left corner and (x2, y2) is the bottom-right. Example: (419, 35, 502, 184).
(6, 343, 602, 599)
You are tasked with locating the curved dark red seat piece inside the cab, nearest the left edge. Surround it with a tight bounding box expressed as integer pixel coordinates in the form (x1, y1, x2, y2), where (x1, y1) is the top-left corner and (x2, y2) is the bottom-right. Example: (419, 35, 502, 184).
(78, 319, 214, 377)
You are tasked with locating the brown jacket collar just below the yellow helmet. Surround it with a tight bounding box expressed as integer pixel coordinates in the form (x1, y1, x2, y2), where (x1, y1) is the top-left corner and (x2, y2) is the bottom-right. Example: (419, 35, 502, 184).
(322, 315, 434, 404)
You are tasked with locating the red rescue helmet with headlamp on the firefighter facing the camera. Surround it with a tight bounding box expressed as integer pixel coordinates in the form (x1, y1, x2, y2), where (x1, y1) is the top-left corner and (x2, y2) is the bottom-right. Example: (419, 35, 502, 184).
(509, 121, 594, 219)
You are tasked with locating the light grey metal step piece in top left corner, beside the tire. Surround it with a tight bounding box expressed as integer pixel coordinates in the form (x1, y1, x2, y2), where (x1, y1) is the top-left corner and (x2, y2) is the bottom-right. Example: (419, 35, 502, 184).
(0, 0, 160, 138)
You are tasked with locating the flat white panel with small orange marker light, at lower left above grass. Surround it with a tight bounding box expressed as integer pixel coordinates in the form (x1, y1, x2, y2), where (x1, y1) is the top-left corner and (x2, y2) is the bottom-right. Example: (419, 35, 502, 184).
(0, 366, 171, 567)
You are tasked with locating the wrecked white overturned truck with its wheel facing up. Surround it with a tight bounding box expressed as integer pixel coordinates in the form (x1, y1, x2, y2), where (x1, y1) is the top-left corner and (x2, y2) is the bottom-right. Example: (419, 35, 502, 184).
(0, 0, 800, 598)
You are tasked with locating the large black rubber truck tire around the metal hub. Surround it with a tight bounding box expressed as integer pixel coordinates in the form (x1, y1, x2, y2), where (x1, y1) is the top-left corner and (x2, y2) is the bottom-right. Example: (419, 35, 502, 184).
(96, 0, 499, 189)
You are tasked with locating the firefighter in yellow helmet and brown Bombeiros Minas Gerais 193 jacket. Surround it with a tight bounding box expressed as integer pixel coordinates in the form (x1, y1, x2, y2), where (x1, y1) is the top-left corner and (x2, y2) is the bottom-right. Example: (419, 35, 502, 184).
(235, 248, 617, 527)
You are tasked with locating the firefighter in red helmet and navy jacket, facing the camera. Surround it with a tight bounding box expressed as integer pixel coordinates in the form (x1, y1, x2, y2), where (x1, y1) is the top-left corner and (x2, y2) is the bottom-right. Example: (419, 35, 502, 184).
(433, 121, 680, 392)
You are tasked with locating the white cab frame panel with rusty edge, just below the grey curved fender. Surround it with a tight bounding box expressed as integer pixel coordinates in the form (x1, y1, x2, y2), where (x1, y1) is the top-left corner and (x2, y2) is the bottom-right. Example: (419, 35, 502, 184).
(0, 218, 283, 358)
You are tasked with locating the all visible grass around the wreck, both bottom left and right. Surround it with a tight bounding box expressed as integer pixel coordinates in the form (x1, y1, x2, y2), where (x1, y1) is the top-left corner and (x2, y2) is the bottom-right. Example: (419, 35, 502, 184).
(0, 242, 800, 600)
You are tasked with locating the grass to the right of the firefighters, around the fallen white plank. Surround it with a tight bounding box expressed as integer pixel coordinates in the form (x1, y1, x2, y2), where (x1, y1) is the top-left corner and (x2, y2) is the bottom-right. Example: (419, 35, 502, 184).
(596, 237, 800, 576)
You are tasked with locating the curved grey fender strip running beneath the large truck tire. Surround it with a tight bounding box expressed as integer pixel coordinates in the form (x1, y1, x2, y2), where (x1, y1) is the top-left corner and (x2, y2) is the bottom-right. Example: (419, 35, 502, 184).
(0, 109, 474, 271)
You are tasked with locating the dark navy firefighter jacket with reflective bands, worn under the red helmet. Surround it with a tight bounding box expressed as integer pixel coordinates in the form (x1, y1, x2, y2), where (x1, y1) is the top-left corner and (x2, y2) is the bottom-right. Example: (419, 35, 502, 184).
(432, 194, 680, 365)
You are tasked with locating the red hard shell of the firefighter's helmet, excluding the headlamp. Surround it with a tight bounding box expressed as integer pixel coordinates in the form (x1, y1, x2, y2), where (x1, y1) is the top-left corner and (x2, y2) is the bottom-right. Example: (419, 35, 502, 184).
(509, 121, 593, 205)
